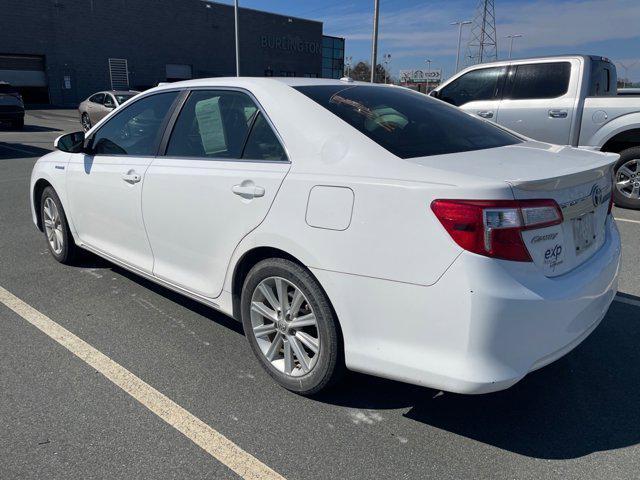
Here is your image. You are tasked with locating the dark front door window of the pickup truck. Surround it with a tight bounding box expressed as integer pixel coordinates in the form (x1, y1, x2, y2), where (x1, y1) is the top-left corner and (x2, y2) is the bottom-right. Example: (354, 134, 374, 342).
(438, 67, 506, 107)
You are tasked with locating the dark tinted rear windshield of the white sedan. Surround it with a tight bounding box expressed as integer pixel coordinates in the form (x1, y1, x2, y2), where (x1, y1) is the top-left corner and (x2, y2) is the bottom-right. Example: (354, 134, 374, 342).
(295, 85, 521, 158)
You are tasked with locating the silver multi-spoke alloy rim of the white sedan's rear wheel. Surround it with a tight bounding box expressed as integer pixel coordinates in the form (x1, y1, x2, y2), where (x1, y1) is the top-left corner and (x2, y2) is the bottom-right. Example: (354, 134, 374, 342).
(251, 277, 320, 377)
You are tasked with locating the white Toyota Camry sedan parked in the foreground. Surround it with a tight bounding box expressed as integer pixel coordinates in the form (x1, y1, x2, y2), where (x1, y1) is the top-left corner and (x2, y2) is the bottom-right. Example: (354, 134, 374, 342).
(31, 78, 620, 394)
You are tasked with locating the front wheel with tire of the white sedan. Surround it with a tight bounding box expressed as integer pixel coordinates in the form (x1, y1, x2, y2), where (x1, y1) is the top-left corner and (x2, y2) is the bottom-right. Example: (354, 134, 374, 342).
(40, 187, 79, 265)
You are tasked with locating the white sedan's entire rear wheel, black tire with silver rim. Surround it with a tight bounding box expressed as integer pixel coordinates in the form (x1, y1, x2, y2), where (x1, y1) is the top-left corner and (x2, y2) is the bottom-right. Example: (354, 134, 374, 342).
(240, 258, 344, 395)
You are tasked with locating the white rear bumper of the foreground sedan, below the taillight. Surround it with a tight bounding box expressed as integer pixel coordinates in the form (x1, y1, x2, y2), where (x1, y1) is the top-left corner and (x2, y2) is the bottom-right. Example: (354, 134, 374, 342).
(313, 219, 620, 394)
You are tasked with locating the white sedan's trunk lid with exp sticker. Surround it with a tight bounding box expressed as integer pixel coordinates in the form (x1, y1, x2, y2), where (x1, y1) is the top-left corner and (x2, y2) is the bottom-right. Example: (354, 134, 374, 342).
(412, 142, 618, 277)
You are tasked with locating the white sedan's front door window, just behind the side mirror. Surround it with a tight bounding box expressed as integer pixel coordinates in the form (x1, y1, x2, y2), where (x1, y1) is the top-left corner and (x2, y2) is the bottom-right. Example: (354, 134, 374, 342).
(90, 92, 178, 156)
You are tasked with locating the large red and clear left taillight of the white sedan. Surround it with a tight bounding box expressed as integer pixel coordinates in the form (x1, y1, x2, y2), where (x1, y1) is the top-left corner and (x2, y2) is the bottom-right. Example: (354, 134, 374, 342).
(431, 200, 562, 262)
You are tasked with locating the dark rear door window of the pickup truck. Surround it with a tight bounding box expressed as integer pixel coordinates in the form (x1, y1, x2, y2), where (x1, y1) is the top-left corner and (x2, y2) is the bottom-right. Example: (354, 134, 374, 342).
(505, 62, 571, 100)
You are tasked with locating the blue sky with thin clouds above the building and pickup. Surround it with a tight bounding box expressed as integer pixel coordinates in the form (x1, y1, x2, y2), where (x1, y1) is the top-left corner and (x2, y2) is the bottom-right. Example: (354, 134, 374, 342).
(218, 0, 640, 81)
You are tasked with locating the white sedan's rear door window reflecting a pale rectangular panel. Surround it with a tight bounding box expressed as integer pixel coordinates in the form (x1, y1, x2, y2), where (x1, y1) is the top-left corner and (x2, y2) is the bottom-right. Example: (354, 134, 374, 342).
(166, 90, 258, 158)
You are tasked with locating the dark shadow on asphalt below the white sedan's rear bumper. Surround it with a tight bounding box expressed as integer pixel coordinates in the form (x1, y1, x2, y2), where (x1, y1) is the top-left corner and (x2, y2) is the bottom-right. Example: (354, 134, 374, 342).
(317, 296, 640, 459)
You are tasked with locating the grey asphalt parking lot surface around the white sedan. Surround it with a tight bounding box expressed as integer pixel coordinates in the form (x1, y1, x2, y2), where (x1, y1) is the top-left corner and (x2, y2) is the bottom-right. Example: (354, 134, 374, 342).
(0, 110, 640, 479)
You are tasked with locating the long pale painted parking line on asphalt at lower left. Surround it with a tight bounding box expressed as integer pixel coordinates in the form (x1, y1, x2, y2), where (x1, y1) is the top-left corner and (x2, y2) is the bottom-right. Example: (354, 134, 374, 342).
(0, 287, 284, 480)
